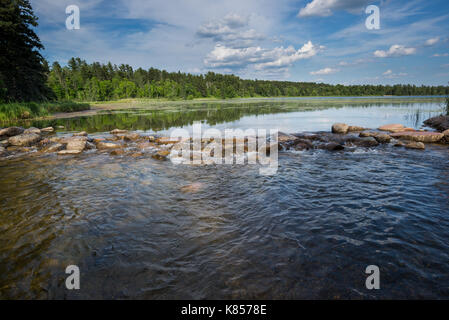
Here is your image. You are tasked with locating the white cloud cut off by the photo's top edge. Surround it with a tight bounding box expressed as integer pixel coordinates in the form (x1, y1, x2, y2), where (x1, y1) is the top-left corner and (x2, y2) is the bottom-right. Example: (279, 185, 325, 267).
(298, 0, 369, 17)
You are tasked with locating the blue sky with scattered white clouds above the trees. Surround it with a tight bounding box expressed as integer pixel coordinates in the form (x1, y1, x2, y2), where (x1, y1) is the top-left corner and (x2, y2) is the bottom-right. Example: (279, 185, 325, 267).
(31, 0, 449, 85)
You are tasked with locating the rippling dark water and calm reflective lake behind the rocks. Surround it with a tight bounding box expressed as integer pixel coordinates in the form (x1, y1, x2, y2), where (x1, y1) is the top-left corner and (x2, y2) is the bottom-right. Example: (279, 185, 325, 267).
(0, 101, 449, 299)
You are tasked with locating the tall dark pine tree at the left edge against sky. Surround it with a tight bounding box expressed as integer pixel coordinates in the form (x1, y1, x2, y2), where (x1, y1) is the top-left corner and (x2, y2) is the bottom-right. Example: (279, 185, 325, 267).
(0, 0, 50, 101)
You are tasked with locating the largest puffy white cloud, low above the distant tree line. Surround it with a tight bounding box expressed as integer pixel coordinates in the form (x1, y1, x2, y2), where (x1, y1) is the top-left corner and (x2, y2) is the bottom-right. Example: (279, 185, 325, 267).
(204, 41, 322, 71)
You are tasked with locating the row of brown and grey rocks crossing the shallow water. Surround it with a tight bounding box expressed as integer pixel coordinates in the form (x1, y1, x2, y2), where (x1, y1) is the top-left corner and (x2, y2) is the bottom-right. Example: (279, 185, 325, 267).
(0, 119, 449, 160)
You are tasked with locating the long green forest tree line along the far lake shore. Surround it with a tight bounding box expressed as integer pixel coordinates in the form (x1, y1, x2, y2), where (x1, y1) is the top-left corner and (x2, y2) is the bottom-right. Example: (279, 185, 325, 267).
(48, 58, 449, 101)
